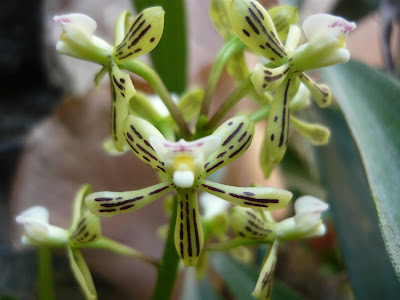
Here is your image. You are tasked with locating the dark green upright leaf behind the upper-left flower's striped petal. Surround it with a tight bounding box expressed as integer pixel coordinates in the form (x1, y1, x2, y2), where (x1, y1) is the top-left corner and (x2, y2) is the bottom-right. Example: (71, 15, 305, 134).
(132, 0, 187, 93)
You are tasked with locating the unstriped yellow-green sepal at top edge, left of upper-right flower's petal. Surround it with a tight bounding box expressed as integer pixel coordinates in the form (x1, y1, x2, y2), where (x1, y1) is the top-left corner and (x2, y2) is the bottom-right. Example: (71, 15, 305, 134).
(209, 0, 235, 42)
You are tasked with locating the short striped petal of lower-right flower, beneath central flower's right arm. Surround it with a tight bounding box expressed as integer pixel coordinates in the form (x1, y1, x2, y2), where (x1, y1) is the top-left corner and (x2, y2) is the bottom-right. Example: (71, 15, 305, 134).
(231, 206, 275, 240)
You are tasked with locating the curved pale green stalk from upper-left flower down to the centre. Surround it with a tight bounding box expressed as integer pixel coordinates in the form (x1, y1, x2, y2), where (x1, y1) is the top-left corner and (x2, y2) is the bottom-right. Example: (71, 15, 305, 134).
(119, 59, 191, 140)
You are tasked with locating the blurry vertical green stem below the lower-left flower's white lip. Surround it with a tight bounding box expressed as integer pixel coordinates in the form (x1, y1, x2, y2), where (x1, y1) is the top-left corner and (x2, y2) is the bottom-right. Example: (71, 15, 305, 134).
(39, 246, 56, 300)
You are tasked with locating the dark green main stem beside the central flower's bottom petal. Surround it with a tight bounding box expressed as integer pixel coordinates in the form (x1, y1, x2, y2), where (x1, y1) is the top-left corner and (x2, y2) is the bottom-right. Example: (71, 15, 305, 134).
(153, 198, 180, 300)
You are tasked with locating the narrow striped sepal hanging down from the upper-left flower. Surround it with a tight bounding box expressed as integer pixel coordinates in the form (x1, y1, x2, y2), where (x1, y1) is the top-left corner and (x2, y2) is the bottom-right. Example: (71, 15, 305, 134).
(110, 62, 136, 151)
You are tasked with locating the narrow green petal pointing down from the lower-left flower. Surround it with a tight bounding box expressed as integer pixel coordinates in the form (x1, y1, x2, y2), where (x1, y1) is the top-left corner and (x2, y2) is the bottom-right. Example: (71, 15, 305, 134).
(67, 247, 97, 300)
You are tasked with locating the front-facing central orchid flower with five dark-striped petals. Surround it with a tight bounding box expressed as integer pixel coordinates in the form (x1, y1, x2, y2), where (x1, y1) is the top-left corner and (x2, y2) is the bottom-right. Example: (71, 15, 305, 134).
(86, 116, 292, 266)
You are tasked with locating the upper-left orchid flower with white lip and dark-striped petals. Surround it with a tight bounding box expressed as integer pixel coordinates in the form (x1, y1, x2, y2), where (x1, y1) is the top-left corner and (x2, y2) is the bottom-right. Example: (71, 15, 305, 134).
(54, 6, 164, 152)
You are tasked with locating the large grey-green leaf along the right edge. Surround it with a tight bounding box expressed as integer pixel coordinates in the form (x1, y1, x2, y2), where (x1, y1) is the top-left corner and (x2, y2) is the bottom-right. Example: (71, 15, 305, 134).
(322, 61, 400, 277)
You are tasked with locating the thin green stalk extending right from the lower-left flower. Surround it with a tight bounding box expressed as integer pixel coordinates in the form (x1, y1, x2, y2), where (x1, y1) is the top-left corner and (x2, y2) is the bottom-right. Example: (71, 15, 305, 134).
(82, 236, 160, 268)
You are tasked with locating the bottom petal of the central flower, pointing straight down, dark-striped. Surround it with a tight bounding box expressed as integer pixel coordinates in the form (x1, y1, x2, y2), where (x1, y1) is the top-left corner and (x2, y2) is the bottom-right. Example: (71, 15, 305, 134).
(175, 189, 204, 267)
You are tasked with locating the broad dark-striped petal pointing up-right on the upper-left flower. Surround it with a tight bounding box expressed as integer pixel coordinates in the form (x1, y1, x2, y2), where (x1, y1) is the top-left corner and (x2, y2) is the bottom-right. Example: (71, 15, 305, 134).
(114, 6, 165, 63)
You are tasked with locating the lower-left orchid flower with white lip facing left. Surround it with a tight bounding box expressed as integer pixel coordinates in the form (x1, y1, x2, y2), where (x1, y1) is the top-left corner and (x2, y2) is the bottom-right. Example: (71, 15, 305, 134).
(16, 185, 102, 299)
